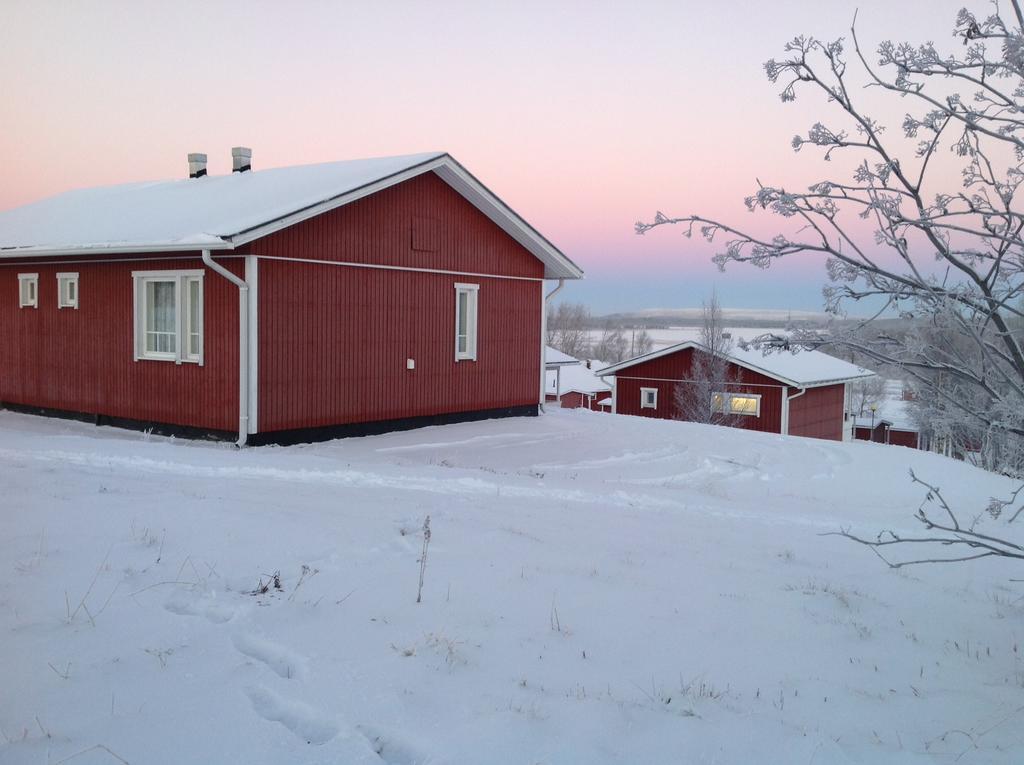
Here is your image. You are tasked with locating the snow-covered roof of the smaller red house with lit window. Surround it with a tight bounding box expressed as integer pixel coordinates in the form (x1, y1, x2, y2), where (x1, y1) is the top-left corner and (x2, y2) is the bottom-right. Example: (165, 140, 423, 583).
(597, 341, 874, 388)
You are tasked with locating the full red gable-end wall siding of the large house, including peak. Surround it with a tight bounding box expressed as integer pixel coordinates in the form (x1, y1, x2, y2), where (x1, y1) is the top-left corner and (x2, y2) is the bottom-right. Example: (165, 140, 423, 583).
(250, 173, 544, 432)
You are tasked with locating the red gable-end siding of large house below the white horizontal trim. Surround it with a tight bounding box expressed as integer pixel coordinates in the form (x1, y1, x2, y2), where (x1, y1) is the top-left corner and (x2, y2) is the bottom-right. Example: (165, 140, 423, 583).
(259, 260, 541, 432)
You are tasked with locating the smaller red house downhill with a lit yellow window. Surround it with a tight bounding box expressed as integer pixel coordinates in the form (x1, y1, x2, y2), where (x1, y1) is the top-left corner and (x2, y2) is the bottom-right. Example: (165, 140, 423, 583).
(598, 342, 873, 440)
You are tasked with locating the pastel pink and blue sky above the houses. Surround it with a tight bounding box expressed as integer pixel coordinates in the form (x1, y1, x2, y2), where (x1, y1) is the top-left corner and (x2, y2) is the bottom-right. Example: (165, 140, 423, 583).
(0, 0, 970, 312)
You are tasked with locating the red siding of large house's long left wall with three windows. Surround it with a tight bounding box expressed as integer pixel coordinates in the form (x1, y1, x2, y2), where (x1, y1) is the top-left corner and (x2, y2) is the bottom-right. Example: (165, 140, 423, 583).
(0, 253, 242, 431)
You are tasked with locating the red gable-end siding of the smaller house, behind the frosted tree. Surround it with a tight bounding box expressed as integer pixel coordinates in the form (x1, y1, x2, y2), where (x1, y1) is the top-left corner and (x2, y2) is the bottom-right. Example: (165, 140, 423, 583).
(615, 348, 792, 433)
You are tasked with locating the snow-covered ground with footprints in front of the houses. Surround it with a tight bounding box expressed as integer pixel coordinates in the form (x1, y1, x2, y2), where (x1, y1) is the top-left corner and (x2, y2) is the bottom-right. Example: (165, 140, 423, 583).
(0, 410, 1024, 765)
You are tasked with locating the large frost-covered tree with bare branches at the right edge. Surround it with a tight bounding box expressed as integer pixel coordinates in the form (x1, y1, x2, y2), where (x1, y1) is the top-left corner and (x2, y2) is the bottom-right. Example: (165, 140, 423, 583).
(636, 0, 1024, 475)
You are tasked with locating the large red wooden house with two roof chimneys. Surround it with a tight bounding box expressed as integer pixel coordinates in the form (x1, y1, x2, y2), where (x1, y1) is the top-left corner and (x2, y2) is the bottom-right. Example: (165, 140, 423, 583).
(0, 150, 582, 443)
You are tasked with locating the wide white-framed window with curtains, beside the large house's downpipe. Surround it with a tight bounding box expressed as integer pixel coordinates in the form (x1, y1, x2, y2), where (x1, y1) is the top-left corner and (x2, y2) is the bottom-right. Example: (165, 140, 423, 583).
(132, 270, 204, 365)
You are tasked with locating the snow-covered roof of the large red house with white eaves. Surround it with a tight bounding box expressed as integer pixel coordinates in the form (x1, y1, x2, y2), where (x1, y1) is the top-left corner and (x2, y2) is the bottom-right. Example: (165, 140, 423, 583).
(0, 152, 583, 279)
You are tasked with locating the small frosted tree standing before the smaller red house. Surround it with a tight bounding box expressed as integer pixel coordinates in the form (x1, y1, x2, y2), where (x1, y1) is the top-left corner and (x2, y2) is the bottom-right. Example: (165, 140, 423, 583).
(672, 292, 740, 425)
